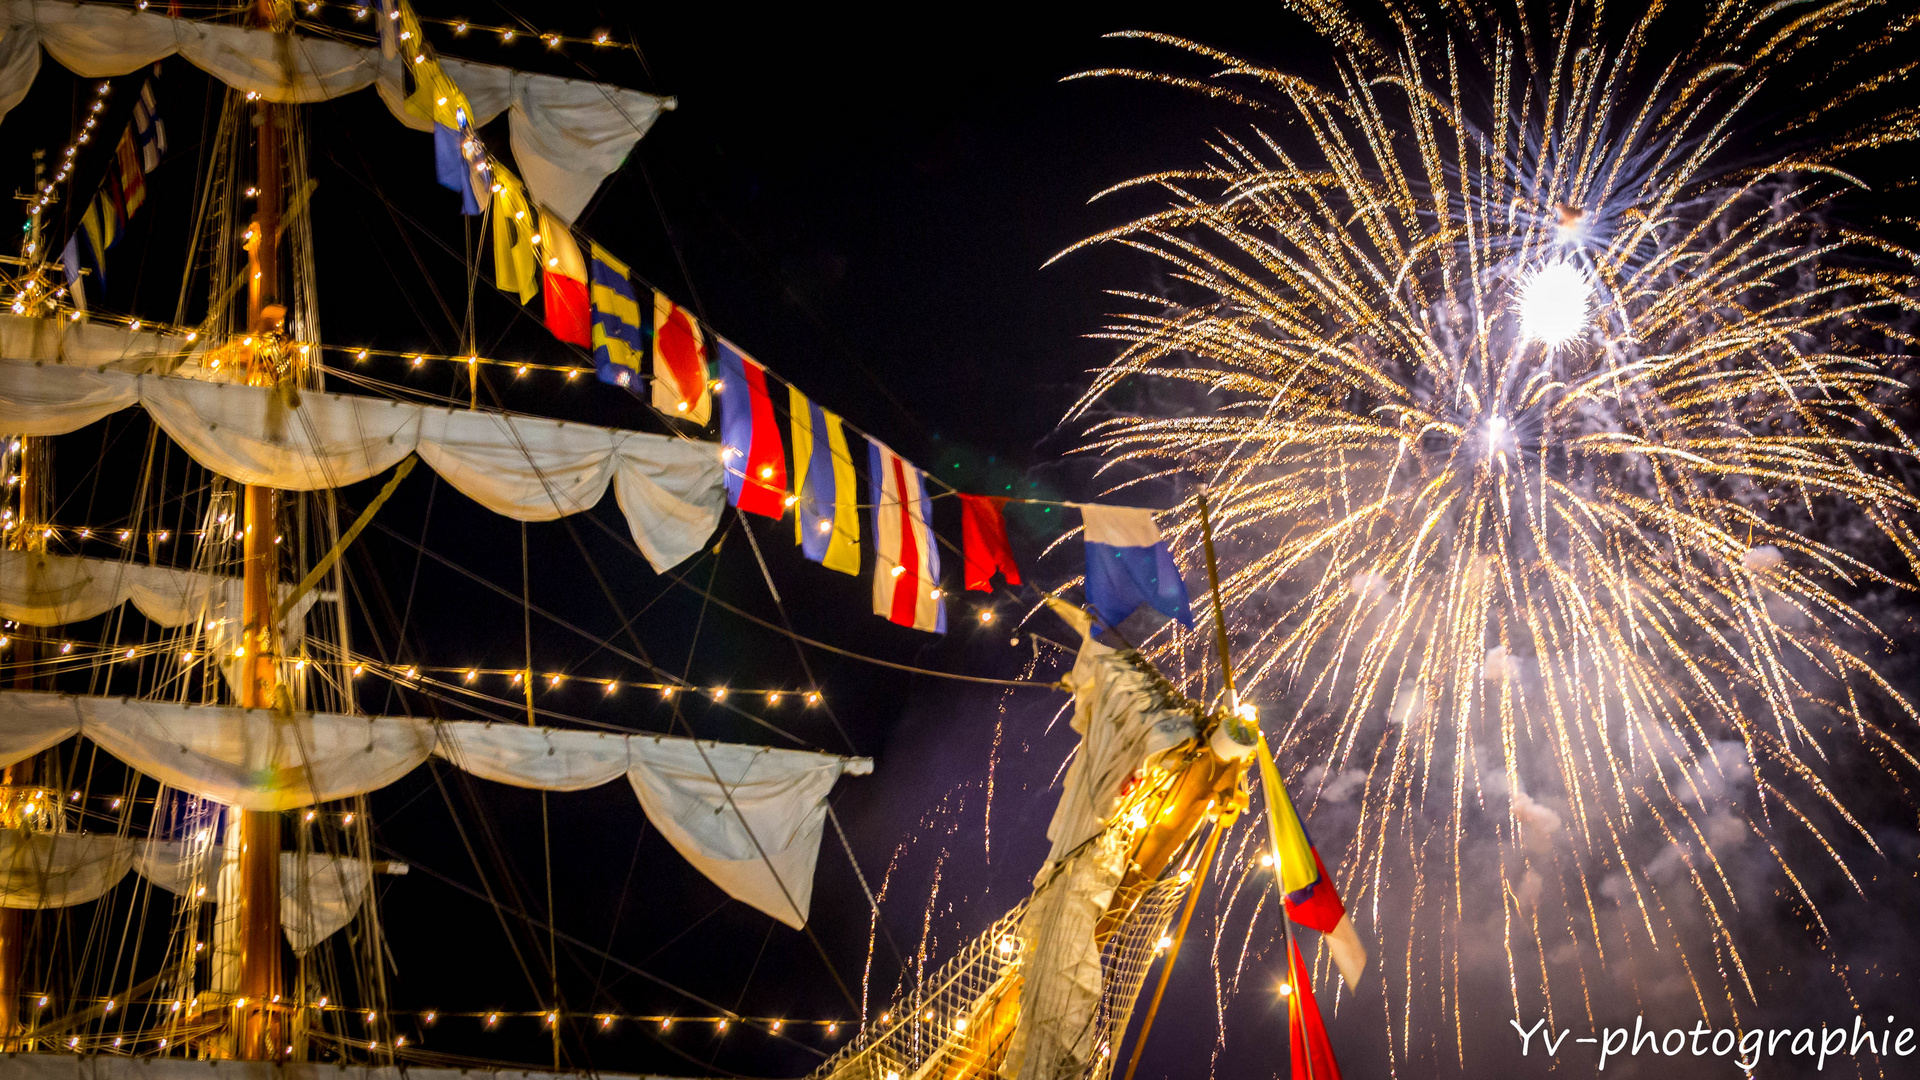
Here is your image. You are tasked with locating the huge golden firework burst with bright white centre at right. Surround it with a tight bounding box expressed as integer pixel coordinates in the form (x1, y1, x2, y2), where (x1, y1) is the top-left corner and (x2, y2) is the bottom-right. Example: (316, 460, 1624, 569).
(1077, 0, 1920, 1053)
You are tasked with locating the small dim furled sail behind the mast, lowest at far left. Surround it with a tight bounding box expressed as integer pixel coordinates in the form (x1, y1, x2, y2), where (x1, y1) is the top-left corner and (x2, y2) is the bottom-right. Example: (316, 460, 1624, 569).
(0, 828, 371, 951)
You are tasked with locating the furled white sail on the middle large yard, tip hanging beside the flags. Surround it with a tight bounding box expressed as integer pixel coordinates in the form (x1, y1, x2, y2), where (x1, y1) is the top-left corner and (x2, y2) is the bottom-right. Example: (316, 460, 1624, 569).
(0, 359, 726, 571)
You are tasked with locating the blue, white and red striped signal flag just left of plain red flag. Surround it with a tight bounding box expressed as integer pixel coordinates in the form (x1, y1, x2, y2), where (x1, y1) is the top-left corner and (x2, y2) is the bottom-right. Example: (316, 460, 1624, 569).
(866, 436, 947, 634)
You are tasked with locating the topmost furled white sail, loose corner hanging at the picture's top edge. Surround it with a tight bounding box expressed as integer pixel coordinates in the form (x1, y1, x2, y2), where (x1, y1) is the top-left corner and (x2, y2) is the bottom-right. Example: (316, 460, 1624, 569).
(0, 0, 674, 223)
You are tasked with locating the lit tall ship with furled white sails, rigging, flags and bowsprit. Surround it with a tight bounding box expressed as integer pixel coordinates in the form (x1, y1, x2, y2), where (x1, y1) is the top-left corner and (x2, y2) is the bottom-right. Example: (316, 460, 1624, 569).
(0, 0, 1367, 1080)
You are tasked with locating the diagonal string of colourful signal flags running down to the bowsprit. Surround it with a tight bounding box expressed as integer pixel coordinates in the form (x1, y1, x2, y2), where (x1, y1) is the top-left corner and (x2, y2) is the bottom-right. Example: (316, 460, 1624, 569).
(376, 0, 1192, 634)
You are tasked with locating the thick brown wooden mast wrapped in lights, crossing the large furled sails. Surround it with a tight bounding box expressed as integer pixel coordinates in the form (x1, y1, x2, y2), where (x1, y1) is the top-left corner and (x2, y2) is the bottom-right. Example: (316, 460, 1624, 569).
(232, 0, 286, 1061)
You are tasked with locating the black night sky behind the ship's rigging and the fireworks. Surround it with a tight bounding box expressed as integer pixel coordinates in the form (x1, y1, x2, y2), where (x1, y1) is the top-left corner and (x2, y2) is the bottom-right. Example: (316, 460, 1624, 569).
(0, 4, 1914, 1080)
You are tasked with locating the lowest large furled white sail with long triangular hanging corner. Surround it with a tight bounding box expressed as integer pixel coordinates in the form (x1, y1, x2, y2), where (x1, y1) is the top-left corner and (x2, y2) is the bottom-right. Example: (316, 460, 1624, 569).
(0, 690, 874, 926)
